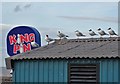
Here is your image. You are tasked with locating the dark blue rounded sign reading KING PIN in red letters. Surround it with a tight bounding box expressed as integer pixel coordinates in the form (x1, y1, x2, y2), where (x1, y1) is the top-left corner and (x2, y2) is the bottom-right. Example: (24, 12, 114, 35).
(7, 26, 41, 56)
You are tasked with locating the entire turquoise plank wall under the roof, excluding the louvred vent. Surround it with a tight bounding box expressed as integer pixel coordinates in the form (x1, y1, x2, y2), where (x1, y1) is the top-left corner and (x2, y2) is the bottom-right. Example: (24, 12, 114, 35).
(13, 59, 120, 83)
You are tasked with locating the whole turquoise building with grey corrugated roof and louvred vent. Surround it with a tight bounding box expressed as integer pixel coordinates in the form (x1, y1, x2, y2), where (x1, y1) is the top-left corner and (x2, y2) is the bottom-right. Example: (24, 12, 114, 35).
(6, 37, 120, 84)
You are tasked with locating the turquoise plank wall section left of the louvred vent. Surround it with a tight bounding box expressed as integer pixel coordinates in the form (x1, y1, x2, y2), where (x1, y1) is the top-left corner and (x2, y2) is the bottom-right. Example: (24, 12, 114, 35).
(13, 60, 67, 82)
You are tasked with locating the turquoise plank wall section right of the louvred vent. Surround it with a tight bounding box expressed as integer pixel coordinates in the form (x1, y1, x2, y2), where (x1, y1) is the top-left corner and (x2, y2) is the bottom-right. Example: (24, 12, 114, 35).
(100, 60, 119, 82)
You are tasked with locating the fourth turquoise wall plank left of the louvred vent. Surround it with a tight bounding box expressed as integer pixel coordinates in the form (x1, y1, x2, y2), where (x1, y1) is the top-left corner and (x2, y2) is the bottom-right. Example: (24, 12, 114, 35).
(48, 60, 54, 82)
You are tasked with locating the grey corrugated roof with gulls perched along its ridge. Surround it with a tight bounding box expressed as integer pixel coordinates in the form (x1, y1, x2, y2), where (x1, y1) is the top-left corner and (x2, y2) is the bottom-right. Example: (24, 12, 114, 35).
(6, 37, 120, 69)
